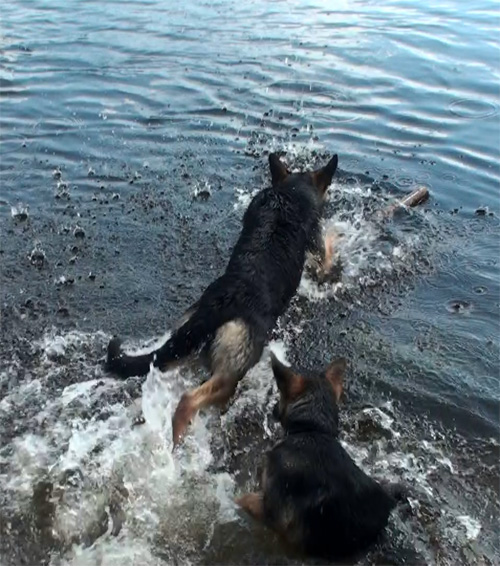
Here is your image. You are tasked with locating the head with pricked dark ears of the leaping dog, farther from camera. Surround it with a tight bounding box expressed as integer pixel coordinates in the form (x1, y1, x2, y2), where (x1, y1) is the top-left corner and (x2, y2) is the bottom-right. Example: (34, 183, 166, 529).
(269, 153, 339, 198)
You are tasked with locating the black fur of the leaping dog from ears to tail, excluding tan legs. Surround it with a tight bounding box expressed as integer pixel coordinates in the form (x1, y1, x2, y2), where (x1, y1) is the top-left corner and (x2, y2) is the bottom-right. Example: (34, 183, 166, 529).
(107, 154, 337, 377)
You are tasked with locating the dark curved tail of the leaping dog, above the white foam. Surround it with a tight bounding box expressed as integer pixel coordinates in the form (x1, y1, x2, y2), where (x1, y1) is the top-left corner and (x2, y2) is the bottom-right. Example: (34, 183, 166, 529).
(106, 314, 218, 378)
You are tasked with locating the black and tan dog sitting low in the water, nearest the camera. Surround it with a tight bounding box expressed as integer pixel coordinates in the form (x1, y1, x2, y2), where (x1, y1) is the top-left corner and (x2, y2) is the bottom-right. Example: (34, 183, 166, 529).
(237, 354, 404, 560)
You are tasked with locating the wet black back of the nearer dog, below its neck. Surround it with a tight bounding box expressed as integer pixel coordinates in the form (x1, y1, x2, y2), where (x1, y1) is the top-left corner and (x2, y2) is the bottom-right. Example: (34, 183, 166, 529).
(264, 433, 395, 559)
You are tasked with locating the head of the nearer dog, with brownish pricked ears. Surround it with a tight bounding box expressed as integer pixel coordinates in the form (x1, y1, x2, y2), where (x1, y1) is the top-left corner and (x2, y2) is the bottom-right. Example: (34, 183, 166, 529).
(271, 352, 346, 436)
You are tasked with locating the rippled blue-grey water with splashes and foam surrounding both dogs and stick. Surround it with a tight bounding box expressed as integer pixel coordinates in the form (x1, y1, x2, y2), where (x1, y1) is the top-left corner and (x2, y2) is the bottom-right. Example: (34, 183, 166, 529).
(0, 0, 500, 566)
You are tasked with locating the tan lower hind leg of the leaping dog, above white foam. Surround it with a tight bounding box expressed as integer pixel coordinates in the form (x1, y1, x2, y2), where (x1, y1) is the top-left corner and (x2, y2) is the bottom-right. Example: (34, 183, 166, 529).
(172, 374, 239, 447)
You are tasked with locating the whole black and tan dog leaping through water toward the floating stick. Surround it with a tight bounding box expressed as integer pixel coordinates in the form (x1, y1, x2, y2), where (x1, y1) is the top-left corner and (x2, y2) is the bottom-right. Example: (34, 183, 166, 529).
(107, 154, 338, 445)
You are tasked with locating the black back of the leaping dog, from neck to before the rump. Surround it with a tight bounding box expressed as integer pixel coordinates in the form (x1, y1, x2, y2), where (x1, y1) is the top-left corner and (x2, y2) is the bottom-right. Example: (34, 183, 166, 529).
(197, 183, 321, 331)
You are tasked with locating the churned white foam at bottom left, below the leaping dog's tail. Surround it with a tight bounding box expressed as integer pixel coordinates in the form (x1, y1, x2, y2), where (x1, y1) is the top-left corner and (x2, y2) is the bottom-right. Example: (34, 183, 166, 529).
(1, 332, 247, 565)
